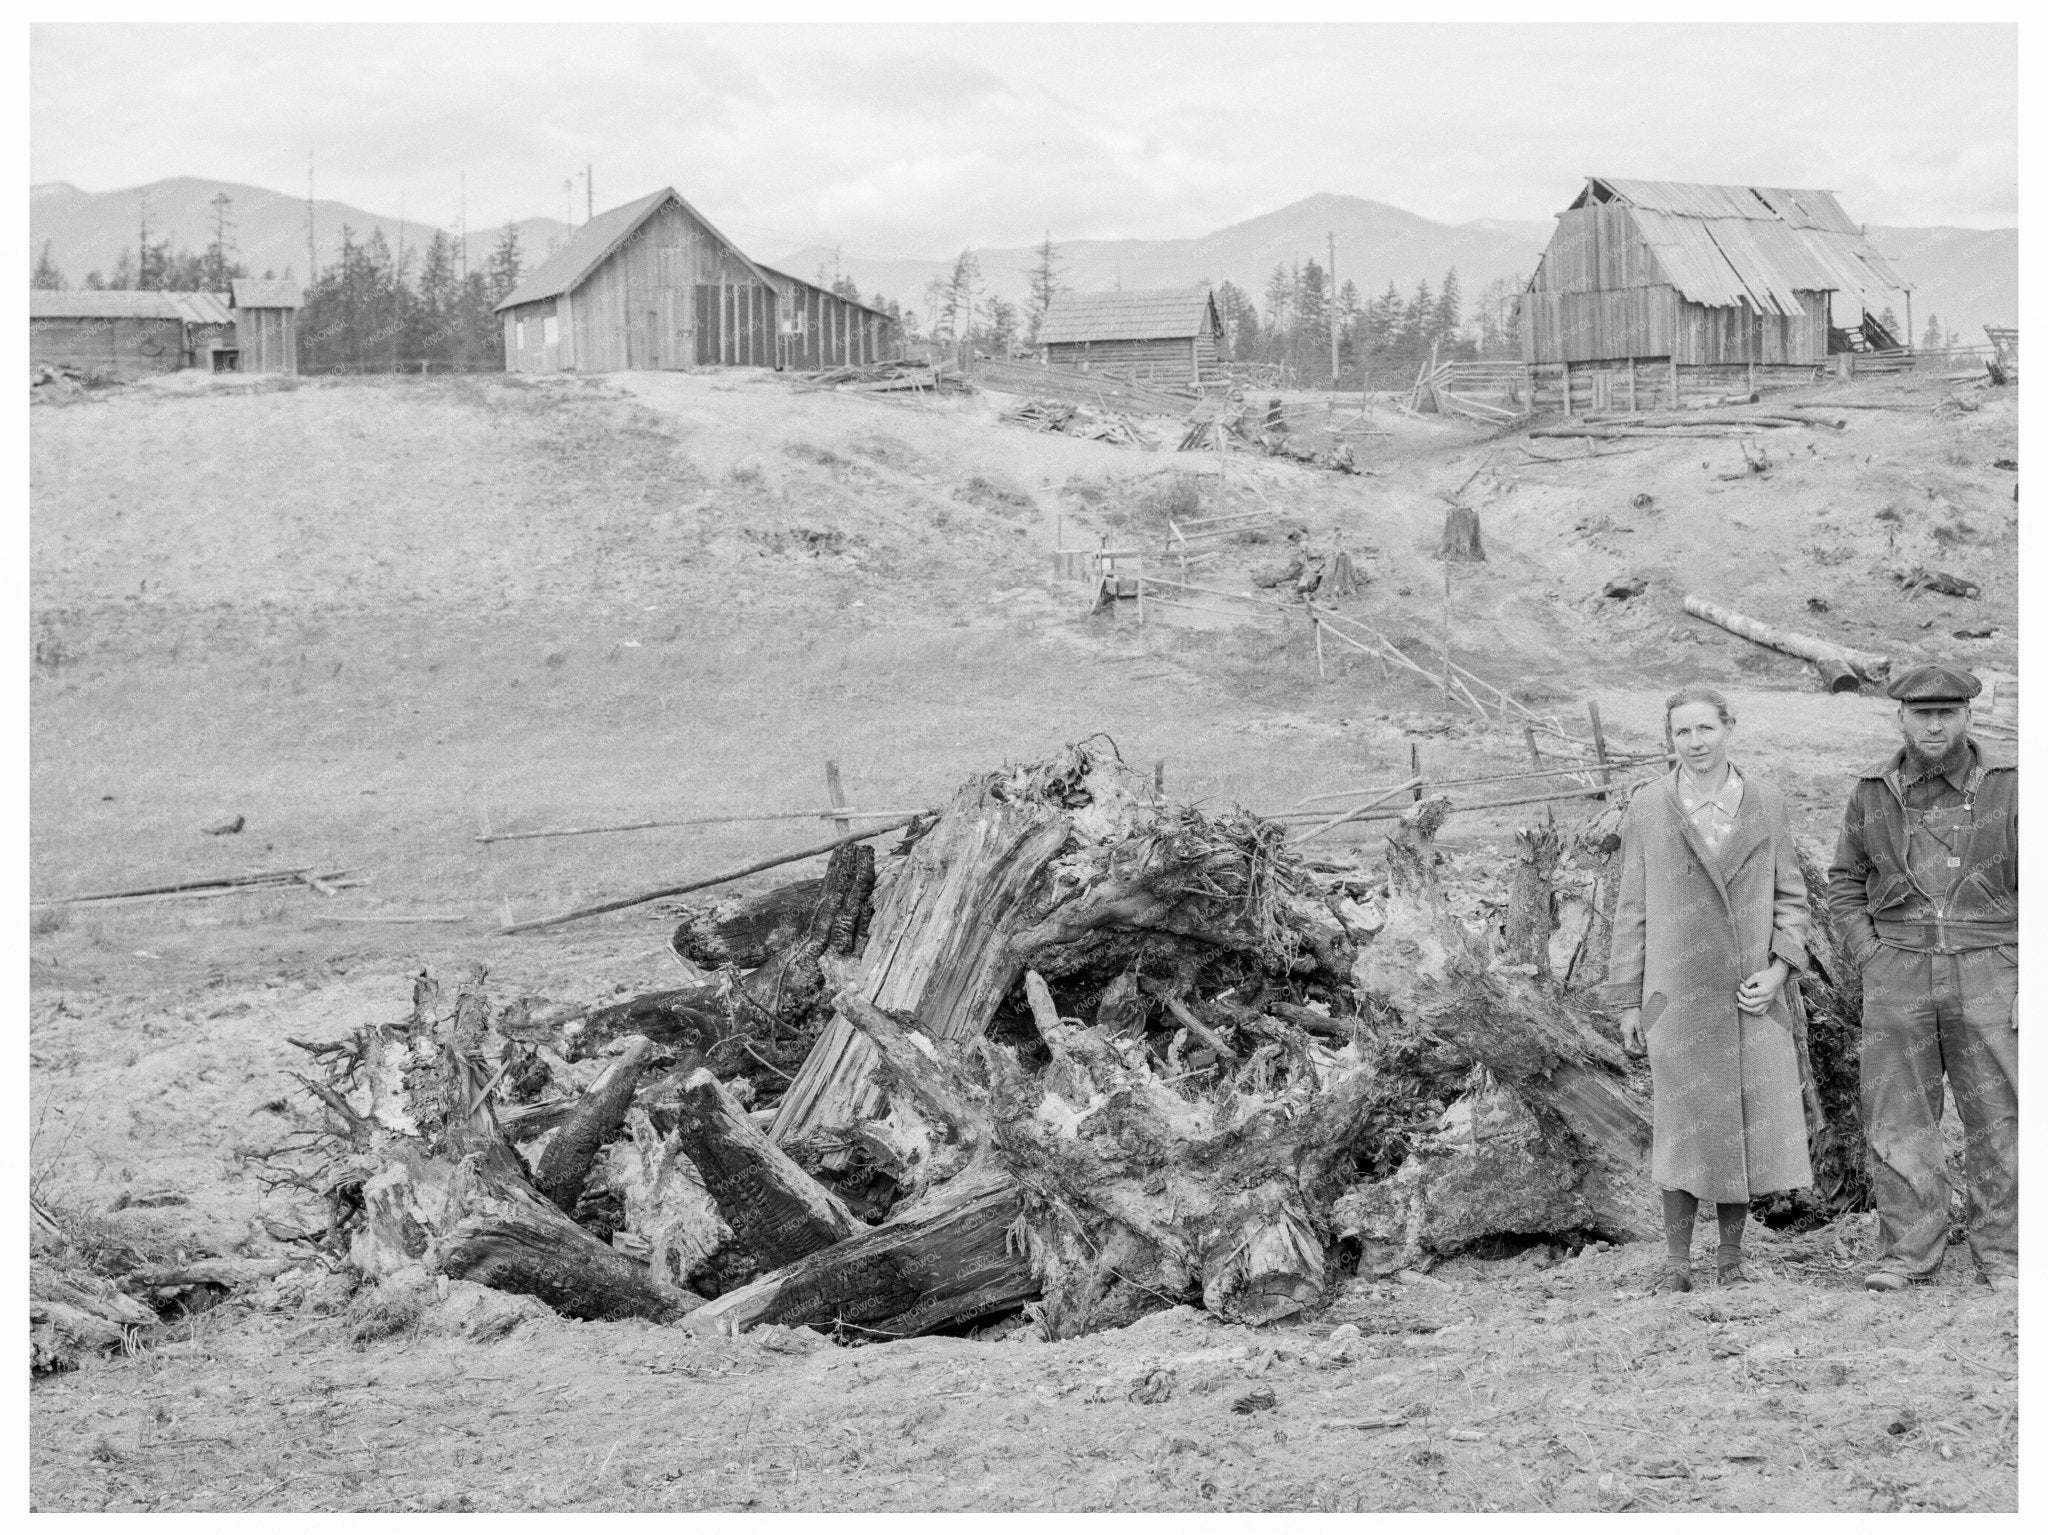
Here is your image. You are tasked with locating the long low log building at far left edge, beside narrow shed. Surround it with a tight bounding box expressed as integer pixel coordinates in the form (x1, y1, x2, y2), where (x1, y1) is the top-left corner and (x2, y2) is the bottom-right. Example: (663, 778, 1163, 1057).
(29, 289, 236, 379)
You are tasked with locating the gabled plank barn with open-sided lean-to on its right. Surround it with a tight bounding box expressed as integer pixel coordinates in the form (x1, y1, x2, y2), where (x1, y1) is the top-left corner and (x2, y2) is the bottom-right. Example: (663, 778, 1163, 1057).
(498, 186, 895, 372)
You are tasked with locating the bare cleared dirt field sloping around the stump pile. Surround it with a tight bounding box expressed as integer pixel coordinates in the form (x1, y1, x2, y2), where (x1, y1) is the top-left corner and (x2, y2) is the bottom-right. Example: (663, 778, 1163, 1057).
(31, 372, 2017, 1510)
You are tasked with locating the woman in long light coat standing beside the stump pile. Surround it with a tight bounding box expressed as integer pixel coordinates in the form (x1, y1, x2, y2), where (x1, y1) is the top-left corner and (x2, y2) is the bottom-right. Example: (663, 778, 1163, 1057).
(1608, 686, 1812, 1289)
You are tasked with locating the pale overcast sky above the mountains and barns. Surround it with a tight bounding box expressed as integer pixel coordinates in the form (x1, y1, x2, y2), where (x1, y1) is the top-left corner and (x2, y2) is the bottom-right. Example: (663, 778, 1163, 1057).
(31, 25, 2019, 258)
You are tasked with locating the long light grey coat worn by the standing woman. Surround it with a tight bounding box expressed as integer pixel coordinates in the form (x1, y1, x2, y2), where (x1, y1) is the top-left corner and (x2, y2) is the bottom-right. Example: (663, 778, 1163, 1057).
(1606, 770, 1812, 1203)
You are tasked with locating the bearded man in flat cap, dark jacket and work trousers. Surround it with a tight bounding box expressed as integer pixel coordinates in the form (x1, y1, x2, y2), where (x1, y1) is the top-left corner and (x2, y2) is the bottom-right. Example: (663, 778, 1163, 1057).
(1827, 665, 2019, 1289)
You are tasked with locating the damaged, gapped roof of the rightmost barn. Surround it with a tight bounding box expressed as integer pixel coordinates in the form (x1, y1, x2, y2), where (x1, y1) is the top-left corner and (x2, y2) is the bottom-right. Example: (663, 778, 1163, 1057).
(1567, 176, 1905, 315)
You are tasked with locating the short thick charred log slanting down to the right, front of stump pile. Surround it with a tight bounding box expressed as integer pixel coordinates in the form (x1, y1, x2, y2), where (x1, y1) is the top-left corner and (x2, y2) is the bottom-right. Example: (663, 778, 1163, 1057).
(676, 1070, 862, 1269)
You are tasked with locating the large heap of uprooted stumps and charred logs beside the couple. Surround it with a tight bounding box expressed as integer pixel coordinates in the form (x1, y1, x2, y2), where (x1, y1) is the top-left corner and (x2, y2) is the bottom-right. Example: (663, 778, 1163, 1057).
(288, 743, 1875, 1339)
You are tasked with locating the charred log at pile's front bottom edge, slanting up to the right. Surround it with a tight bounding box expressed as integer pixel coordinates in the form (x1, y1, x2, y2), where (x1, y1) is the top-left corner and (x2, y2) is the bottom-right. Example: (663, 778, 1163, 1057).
(686, 1173, 1038, 1339)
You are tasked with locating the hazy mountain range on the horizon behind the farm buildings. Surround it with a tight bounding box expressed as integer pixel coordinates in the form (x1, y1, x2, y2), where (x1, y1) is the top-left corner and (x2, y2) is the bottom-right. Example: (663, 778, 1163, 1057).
(29, 176, 2019, 342)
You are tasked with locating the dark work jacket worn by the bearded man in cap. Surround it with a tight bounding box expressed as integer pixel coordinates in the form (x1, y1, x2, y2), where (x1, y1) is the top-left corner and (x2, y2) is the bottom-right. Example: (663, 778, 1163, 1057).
(1827, 737, 2019, 964)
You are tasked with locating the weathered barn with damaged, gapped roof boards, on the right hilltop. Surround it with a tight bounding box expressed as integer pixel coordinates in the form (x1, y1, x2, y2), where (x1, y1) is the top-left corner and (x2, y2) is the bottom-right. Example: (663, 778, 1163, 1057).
(1522, 176, 1903, 407)
